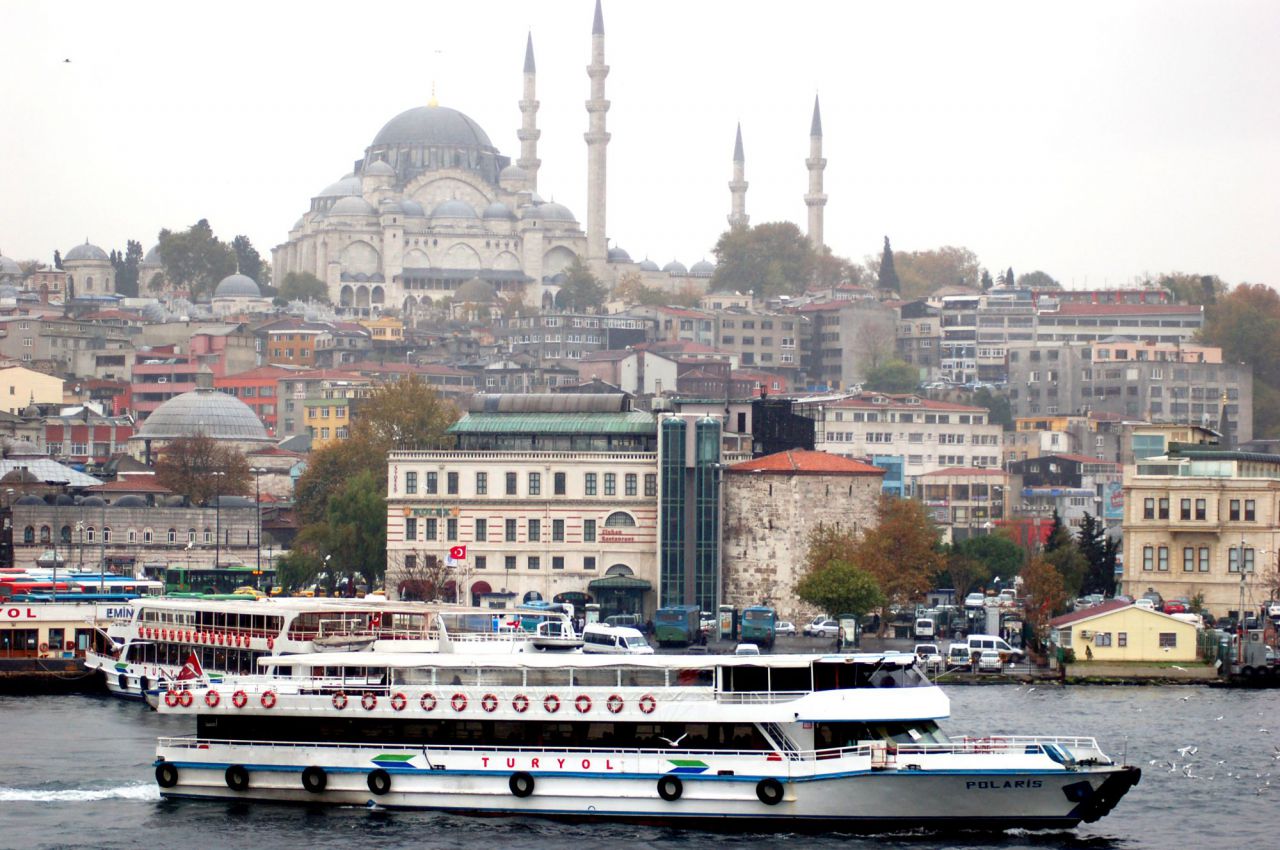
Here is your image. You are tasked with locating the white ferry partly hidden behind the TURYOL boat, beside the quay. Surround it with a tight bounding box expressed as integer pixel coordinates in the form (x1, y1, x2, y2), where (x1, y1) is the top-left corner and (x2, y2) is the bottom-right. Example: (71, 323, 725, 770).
(92, 597, 581, 702)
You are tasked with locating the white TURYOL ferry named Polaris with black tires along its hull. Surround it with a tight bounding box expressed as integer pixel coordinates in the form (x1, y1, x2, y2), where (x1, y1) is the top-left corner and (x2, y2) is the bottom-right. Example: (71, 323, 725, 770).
(155, 652, 1140, 831)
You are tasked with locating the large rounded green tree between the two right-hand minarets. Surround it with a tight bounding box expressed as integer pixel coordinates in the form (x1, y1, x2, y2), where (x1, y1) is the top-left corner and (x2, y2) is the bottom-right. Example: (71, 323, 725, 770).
(710, 221, 817, 298)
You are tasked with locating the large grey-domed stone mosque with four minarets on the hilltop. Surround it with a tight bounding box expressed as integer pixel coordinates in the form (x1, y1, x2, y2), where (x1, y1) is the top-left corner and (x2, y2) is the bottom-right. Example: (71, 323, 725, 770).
(271, 0, 826, 317)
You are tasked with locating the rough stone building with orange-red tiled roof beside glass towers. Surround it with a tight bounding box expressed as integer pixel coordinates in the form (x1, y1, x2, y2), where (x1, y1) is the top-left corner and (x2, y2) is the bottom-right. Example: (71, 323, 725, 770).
(723, 449, 884, 622)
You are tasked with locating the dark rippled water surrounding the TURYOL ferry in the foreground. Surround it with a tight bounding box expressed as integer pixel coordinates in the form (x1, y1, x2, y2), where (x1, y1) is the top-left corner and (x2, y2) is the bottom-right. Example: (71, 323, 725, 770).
(0, 685, 1280, 850)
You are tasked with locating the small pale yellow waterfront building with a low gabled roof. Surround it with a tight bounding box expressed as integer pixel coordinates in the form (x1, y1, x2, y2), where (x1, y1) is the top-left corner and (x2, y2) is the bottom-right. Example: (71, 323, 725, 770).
(1050, 600, 1196, 663)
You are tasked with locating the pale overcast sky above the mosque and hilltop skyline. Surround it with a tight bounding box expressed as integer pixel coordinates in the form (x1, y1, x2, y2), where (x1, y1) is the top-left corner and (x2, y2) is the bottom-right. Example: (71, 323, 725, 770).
(0, 0, 1280, 287)
